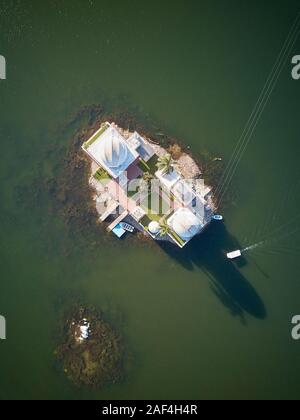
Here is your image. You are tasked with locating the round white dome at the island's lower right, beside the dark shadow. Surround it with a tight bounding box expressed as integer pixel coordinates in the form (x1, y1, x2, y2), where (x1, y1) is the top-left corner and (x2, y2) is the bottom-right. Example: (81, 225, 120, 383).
(172, 209, 202, 240)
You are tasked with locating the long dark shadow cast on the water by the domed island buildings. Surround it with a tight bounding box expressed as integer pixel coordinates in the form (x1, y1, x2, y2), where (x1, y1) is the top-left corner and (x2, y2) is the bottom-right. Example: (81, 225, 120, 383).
(160, 222, 267, 322)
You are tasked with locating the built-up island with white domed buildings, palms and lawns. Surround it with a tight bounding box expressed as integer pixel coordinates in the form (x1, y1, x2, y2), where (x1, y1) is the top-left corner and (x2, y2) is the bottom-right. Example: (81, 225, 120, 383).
(82, 122, 215, 248)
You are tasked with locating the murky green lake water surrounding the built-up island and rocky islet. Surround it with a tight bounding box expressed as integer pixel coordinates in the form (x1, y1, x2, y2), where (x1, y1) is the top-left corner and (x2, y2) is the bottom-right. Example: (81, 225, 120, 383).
(0, 0, 300, 399)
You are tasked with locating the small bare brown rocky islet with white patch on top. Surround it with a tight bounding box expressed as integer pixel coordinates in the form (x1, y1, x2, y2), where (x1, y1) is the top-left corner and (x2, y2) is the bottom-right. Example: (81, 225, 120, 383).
(55, 304, 124, 389)
